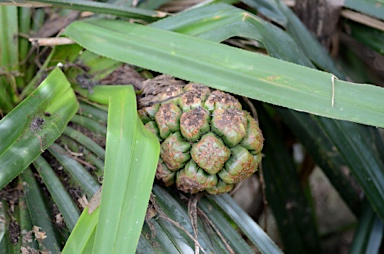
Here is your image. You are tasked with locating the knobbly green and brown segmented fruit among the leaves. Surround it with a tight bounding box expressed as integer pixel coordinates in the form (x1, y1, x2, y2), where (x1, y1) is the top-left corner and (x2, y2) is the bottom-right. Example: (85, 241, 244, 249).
(139, 75, 264, 194)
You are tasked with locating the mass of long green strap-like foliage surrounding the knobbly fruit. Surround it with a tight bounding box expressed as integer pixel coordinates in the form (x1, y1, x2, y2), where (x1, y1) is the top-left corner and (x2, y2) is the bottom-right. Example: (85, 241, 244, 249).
(0, 0, 384, 253)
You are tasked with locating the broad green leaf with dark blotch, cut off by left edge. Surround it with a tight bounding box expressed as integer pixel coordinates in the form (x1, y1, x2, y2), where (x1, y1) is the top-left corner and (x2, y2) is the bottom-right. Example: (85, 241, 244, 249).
(0, 69, 78, 188)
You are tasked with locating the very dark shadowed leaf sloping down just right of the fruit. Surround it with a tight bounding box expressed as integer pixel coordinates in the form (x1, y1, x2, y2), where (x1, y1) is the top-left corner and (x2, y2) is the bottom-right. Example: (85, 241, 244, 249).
(258, 104, 321, 253)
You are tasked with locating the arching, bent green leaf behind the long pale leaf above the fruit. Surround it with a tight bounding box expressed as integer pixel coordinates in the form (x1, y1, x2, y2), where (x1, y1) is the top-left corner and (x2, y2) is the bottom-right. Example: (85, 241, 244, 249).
(150, 4, 312, 66)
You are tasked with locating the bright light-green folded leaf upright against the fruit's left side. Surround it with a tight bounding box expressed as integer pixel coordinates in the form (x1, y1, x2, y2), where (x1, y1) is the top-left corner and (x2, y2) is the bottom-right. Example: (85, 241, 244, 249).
(88, 86, 160, 253)
